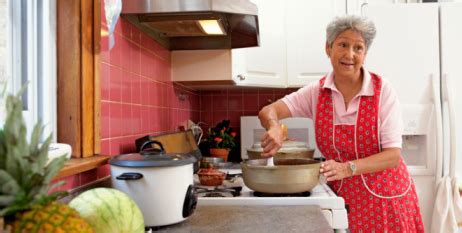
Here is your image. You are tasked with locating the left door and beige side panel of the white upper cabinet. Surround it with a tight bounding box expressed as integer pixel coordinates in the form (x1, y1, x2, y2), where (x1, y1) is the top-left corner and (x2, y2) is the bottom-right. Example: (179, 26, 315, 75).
(172, 0, 287, 88)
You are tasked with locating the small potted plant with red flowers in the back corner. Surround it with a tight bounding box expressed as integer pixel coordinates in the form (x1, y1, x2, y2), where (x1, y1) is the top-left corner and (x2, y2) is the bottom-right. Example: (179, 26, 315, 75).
(206, 120, 236, 150)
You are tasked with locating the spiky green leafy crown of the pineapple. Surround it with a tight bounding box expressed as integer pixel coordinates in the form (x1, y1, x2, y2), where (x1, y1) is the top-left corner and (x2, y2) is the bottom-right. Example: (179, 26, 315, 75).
(0, 89, 66, 219)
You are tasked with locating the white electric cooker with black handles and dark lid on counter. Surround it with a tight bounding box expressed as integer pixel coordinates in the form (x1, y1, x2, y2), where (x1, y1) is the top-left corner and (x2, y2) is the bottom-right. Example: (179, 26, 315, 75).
(109, 141, 197, 227)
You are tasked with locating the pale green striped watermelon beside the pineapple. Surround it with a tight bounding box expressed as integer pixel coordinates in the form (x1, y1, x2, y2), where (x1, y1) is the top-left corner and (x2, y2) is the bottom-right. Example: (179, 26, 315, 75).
(69, 188, 145, 233)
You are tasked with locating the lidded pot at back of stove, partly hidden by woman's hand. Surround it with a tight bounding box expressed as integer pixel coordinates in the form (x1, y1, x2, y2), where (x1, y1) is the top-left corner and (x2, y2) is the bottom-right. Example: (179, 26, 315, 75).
(247, 141, 314, 160)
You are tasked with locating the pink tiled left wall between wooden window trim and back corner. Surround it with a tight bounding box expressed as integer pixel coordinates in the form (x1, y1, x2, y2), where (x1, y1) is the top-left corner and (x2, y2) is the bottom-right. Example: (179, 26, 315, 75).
(101, 17, 200, 155)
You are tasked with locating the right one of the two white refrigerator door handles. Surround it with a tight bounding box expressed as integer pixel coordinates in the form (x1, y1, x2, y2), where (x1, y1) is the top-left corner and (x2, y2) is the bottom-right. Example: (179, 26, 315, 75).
(442, 74, 456, 177)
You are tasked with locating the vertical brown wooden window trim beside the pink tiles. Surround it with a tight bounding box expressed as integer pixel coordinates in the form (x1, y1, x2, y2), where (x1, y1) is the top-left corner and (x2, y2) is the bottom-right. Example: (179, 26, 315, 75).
(56, 0, 101, 158)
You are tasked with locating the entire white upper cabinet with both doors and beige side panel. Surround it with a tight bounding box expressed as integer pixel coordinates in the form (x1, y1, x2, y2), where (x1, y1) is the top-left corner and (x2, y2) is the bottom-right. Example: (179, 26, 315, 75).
(172, 0, 362, 88)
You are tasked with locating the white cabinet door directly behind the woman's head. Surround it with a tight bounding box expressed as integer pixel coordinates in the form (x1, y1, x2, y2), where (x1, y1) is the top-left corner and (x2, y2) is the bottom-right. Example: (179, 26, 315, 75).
(286, 0, 346, 87)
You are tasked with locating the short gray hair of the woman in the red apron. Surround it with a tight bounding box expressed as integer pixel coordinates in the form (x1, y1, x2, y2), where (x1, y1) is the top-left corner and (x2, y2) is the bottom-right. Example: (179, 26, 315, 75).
(326, 15, 376, 51)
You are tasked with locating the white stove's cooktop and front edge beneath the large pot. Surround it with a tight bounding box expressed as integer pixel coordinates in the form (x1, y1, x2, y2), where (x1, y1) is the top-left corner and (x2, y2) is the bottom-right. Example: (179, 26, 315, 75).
(194, 169, 348, 232)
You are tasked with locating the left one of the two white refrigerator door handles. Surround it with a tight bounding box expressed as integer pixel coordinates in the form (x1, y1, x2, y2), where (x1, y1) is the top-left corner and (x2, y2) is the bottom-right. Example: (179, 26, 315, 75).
(430, 74, 443, 183)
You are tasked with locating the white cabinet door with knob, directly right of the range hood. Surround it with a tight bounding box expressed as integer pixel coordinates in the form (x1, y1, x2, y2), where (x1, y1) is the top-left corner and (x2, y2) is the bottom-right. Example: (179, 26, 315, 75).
(232, 0, 286, 88)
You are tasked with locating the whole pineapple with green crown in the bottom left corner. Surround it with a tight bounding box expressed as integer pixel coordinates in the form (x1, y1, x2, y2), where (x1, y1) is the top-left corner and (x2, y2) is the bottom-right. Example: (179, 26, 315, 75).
(0, 88, 93, 233)
